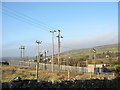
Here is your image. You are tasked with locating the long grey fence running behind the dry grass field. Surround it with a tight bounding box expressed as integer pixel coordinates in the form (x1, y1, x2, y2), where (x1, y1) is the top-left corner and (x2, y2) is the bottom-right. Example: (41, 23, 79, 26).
(9, 60, 87, 74)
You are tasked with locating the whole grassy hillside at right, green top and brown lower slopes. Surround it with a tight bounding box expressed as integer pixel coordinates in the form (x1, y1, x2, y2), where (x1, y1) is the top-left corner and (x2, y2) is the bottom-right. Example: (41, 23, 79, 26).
(56, 44, 120, 65)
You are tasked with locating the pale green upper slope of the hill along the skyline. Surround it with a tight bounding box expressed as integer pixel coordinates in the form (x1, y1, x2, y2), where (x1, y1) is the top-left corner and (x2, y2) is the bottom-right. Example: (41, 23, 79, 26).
(61, 44, 118, 57)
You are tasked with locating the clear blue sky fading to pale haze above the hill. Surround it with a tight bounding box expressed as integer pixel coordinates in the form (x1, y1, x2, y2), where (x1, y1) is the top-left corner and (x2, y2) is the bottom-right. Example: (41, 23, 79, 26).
(0, 2, 118, 57)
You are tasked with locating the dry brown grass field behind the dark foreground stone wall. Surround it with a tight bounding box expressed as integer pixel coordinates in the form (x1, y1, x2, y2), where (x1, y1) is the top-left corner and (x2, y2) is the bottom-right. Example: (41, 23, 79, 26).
(2, 66, 115, 82)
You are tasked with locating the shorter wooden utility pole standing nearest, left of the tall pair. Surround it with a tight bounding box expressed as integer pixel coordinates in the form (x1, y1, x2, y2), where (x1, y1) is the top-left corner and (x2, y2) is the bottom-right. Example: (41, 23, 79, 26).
(36, 40, 42, 81)
